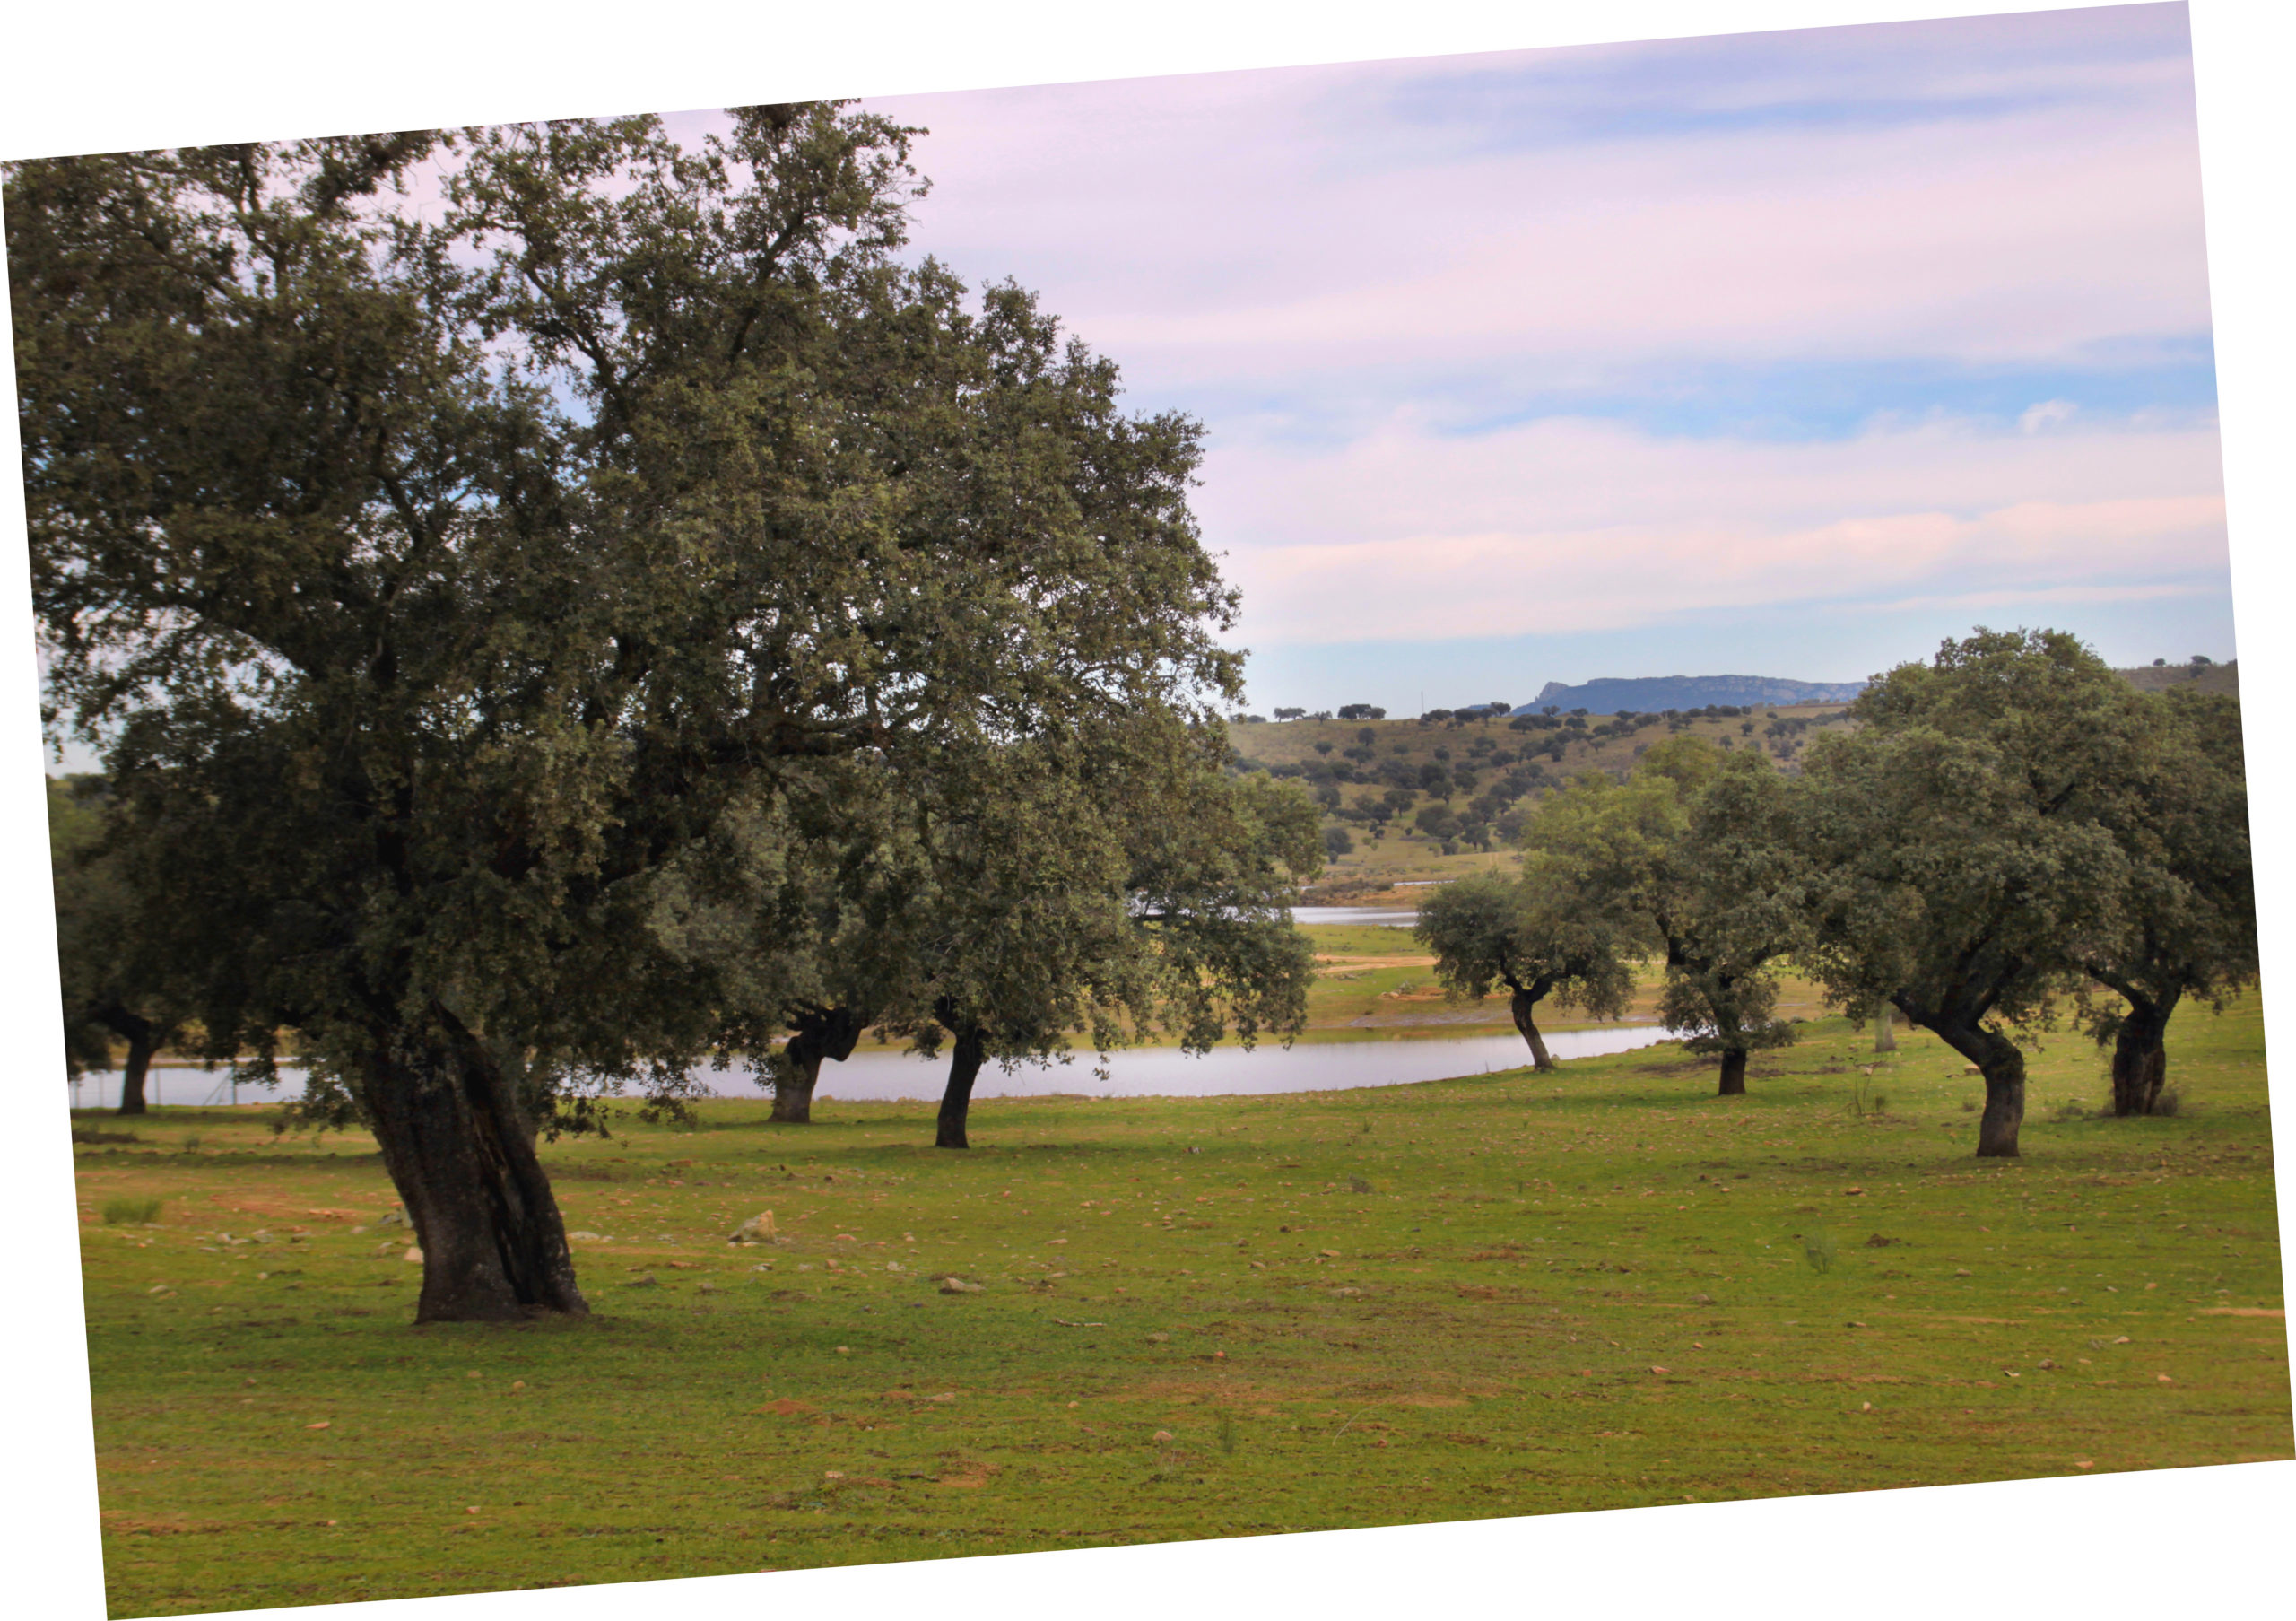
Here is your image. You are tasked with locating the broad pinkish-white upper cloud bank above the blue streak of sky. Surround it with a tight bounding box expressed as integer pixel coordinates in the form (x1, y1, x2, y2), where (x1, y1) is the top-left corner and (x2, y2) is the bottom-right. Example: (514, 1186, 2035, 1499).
(884, 13, 2209, 397)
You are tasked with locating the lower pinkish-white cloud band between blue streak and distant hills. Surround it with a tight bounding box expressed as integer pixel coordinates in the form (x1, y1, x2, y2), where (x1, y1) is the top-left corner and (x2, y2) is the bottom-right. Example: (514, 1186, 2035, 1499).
(1198, 415, 2227, 645)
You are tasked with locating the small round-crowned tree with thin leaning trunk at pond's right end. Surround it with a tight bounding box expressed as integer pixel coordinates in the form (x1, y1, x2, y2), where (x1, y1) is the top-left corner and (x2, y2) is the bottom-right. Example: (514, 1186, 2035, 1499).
(1412, 863, 1635, 1072)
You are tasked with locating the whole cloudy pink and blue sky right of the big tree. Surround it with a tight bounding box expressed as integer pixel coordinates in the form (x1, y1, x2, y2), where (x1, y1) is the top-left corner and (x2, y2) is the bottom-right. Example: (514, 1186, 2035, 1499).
(839, 4, 2234, 711)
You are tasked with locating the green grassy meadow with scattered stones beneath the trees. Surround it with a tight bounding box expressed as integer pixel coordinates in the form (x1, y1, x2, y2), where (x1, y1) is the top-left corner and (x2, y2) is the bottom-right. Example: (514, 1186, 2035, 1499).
(81, 998, 2292, 1614)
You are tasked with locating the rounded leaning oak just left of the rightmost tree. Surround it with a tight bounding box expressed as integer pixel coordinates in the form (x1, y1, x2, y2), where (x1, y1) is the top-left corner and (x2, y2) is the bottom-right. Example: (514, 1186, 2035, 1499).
(1805, 629, 2158, 1157)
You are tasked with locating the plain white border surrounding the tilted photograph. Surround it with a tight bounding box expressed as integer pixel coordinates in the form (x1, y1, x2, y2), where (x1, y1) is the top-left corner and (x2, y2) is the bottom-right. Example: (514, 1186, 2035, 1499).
(0, 0, 2296, 1621)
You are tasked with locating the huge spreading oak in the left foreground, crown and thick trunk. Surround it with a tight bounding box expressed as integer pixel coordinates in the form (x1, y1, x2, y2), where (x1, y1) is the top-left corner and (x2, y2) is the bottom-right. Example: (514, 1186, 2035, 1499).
(4, 106, 1238, 1320)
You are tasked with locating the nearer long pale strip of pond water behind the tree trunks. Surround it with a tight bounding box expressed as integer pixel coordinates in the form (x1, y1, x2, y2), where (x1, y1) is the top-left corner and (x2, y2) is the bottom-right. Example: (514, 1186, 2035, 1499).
(57, 1024, 1667, 1109)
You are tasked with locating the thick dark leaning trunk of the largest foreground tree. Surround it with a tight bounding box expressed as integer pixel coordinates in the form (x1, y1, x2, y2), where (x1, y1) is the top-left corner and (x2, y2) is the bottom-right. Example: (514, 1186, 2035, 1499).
(361, 1008, 590, 1322)
